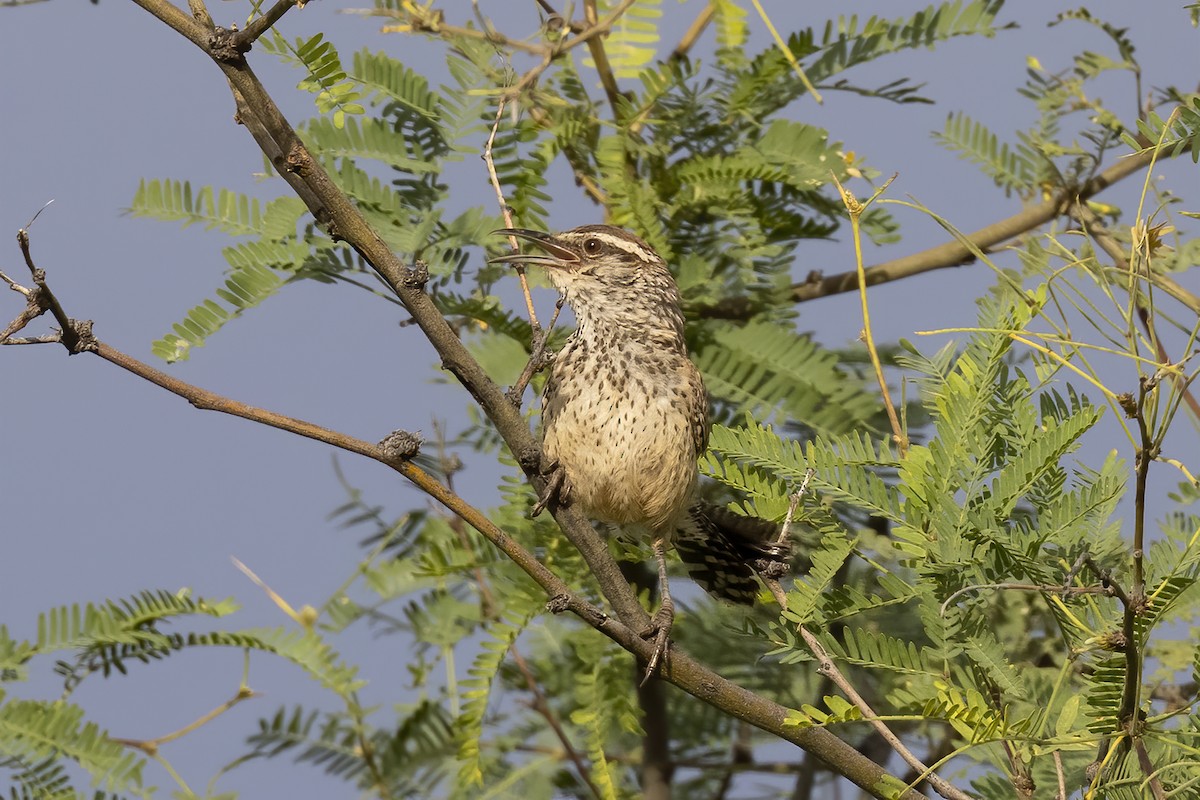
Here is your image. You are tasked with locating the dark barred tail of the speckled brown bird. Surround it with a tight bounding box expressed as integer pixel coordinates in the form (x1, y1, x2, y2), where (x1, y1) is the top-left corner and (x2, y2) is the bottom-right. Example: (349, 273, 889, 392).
(674, 503, 791, 606)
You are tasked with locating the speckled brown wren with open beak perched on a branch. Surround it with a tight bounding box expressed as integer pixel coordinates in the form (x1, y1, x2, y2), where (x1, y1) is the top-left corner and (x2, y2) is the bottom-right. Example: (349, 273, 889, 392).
(491, 224, 788, 682)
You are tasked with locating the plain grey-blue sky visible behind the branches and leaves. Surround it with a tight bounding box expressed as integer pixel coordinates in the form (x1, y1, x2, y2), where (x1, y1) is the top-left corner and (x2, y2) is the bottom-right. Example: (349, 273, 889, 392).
(0, 0, 1200, 798)
